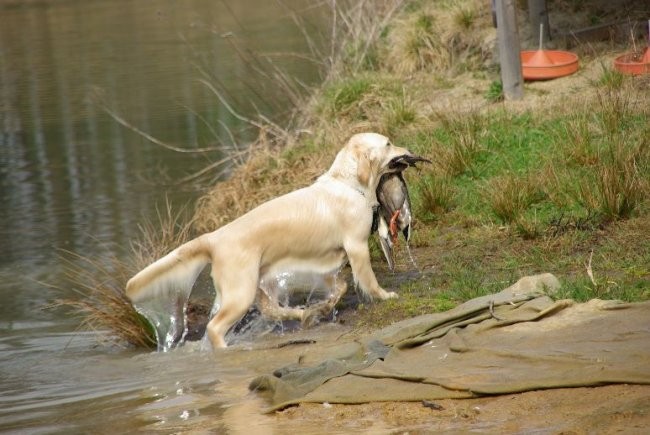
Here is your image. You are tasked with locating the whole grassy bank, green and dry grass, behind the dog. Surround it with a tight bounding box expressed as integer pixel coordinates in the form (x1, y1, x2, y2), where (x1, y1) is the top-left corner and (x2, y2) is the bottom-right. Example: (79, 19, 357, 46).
(64, 0, 650, 348)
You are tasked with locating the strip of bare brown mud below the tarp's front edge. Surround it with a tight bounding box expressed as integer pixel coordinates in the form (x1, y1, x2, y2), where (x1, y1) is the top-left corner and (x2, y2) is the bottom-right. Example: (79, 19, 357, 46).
(274, 385, 650, 434)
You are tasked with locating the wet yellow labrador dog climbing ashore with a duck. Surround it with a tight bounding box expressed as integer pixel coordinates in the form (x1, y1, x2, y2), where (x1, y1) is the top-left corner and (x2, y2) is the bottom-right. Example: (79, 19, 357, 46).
(126, 133, 419, 348)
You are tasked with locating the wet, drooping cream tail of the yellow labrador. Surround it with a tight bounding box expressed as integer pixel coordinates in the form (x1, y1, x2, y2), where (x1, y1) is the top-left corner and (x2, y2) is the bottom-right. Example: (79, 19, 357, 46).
(126, 235, 212, 302)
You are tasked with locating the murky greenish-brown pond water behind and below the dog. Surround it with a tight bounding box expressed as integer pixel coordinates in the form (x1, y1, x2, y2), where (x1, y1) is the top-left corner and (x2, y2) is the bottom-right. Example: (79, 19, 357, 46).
(0, 0, 330, 433)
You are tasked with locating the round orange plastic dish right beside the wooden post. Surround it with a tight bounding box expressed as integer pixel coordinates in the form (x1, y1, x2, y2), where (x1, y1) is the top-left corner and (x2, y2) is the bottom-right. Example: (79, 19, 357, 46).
(521, 50, 578, 80)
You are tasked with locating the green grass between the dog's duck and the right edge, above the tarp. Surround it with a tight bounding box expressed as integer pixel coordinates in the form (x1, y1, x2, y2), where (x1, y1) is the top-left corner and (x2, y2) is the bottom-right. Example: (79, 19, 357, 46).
(352, 78, 650, 324)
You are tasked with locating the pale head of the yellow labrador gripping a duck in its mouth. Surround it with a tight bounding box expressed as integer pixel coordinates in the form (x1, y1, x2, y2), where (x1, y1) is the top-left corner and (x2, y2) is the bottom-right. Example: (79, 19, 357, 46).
(329, 133, 428, 192)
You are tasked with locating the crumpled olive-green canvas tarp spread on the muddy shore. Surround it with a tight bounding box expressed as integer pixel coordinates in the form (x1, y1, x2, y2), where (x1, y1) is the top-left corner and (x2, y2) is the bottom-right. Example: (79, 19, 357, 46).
(250, 274, 650, 411)
